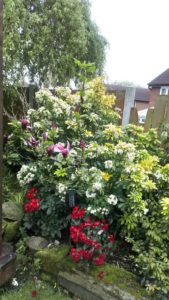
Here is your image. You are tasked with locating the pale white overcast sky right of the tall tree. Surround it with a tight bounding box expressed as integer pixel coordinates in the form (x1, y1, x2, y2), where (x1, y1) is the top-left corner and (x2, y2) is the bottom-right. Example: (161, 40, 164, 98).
(91, 0, 169, 87)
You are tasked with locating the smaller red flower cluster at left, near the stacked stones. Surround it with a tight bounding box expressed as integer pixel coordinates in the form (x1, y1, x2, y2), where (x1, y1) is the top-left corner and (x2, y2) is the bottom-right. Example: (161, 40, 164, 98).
(24, 188, 40, 213)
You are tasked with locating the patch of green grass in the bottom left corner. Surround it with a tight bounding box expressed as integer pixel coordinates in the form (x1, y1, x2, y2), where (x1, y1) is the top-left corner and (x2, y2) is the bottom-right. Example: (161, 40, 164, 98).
(0, 280, 71, 300)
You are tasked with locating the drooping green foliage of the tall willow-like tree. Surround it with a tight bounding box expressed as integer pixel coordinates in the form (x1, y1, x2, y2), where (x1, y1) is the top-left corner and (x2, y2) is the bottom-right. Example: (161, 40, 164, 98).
(4, 0, 107, 86)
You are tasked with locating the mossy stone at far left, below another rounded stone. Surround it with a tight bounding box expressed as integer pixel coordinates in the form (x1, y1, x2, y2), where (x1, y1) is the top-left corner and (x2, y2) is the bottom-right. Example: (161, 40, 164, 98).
(2, 220, 20, 242)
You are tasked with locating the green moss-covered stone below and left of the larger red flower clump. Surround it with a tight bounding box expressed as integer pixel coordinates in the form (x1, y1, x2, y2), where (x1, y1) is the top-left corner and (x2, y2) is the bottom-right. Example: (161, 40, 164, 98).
(35, 245, 75, 280)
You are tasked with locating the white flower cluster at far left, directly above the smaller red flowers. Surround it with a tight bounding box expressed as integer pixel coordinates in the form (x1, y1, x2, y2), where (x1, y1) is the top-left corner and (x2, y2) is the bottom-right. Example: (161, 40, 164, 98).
(17, 165, 37, 186)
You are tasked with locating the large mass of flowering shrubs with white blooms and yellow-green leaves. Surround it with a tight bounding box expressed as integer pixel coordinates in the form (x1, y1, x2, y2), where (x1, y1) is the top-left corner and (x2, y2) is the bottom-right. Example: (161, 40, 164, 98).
(4, 67, 169, 297)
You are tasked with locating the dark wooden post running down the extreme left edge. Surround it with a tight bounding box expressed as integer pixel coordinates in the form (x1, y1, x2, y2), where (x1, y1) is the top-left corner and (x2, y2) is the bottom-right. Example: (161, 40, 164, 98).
(0, 0, 3, 256)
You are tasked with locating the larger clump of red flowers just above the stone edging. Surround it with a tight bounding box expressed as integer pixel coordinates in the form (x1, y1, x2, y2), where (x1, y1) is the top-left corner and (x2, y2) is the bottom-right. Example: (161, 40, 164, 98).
(70, 206, 115, 266)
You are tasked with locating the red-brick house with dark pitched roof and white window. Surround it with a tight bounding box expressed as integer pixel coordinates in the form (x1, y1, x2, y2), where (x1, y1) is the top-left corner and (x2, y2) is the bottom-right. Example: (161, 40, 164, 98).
(148, 69, 169, 107)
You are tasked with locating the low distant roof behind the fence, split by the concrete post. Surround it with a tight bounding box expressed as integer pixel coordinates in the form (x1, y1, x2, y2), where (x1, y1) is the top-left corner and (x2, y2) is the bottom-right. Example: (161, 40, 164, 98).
(106, 84, 149, 102)
